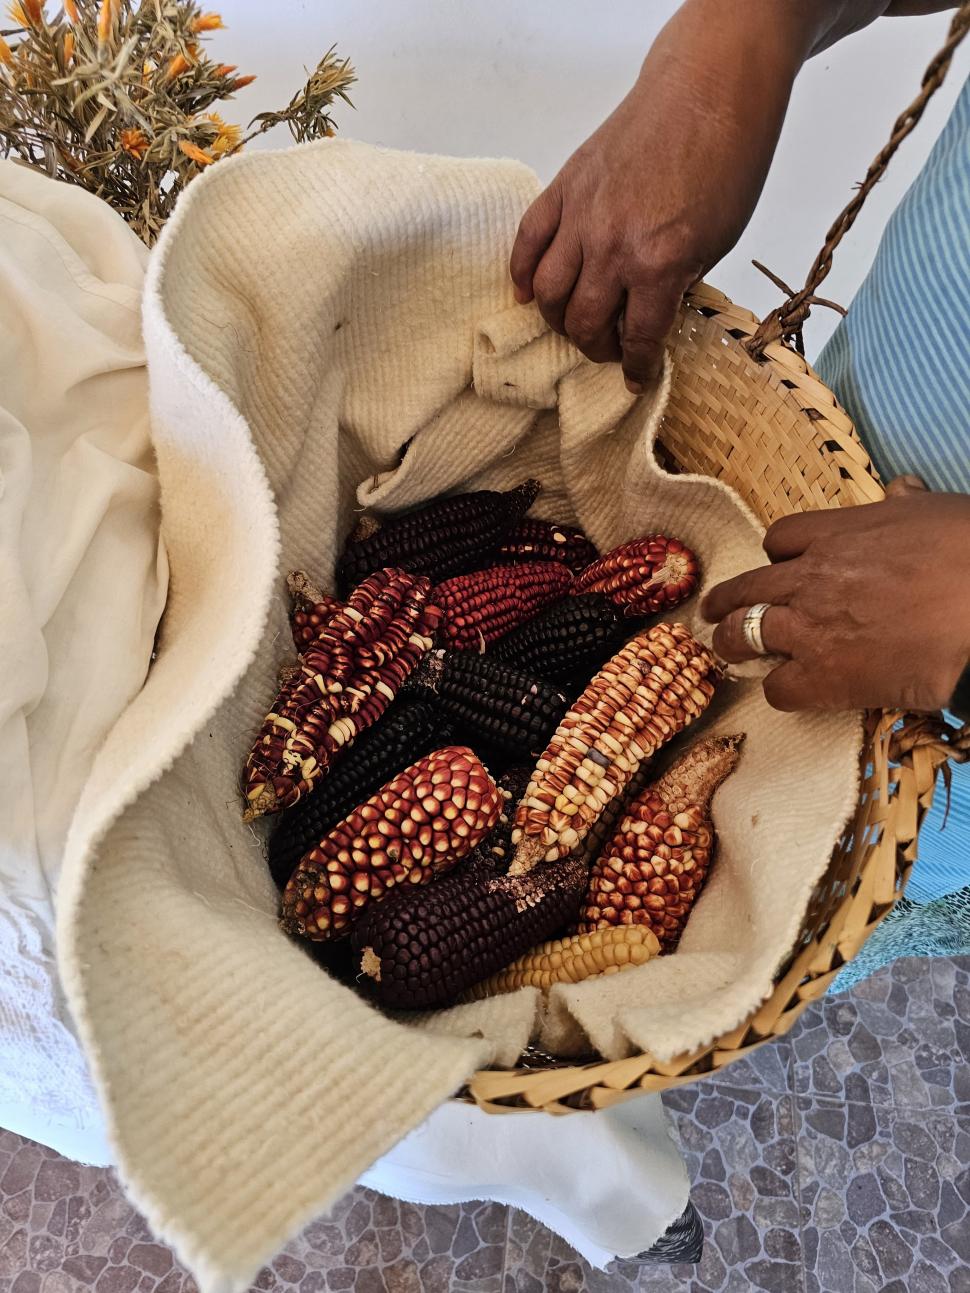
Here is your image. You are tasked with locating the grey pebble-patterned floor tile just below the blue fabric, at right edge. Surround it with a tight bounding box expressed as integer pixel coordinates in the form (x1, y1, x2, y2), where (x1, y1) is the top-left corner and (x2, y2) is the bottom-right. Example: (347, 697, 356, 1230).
(792, 958, 970, 1111)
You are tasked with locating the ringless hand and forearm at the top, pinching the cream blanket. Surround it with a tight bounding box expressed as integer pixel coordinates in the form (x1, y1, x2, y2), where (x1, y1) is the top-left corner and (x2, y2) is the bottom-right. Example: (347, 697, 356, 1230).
(510, 0, 848, 393)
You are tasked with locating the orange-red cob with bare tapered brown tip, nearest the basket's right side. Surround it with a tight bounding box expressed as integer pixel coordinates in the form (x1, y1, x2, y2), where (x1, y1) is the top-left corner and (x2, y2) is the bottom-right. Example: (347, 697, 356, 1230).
(579, 736, 744, 952)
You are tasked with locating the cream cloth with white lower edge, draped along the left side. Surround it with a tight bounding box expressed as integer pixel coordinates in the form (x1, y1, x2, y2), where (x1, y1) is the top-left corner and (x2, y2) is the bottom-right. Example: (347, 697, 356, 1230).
(0, 162, 167, 1161)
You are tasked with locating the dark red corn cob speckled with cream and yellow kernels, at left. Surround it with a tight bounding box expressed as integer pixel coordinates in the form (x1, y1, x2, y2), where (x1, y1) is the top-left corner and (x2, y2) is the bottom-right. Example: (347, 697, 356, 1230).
(243, 570, 441, 821)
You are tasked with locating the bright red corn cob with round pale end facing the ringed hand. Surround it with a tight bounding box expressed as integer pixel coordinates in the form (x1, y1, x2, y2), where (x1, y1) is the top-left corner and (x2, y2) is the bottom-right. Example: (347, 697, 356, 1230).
(573, 534, 697, 615)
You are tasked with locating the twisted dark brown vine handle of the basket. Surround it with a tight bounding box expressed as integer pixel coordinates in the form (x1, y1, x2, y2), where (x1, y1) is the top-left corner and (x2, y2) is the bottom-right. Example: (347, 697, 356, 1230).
(744, 0, 970, 359)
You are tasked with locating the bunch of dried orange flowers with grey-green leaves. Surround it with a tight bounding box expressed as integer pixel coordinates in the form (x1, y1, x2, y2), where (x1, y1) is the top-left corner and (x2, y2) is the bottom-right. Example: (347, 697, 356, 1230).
(0, 0, 354, 246)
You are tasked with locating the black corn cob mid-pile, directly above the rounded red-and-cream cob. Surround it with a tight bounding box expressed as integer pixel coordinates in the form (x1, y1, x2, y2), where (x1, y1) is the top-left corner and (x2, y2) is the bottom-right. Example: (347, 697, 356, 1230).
(414, 650, 569, 759)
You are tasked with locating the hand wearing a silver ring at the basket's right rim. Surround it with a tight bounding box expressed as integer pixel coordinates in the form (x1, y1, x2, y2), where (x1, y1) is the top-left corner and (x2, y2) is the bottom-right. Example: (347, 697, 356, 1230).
(702, 478, 970, 711)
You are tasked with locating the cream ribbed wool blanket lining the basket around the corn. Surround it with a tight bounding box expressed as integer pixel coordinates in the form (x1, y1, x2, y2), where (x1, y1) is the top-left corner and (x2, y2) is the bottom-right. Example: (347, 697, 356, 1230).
(53, 141, 859, 1290)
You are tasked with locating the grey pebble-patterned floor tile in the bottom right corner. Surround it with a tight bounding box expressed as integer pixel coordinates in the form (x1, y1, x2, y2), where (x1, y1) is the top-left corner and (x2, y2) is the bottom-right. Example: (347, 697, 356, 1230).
(798, 1096, 970, 1293)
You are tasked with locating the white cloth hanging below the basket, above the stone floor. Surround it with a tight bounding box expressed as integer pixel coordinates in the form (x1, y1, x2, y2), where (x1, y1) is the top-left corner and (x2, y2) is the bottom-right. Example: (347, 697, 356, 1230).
(361, 1095, 689, 1270)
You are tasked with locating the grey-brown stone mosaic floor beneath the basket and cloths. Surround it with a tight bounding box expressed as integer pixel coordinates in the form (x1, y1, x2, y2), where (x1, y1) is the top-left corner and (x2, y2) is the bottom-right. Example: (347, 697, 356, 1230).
(0, 959, 970, 1293)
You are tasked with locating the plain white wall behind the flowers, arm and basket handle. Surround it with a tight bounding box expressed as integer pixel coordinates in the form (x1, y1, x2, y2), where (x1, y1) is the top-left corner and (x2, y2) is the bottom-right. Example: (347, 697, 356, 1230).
(213, 0, 970, 353)
